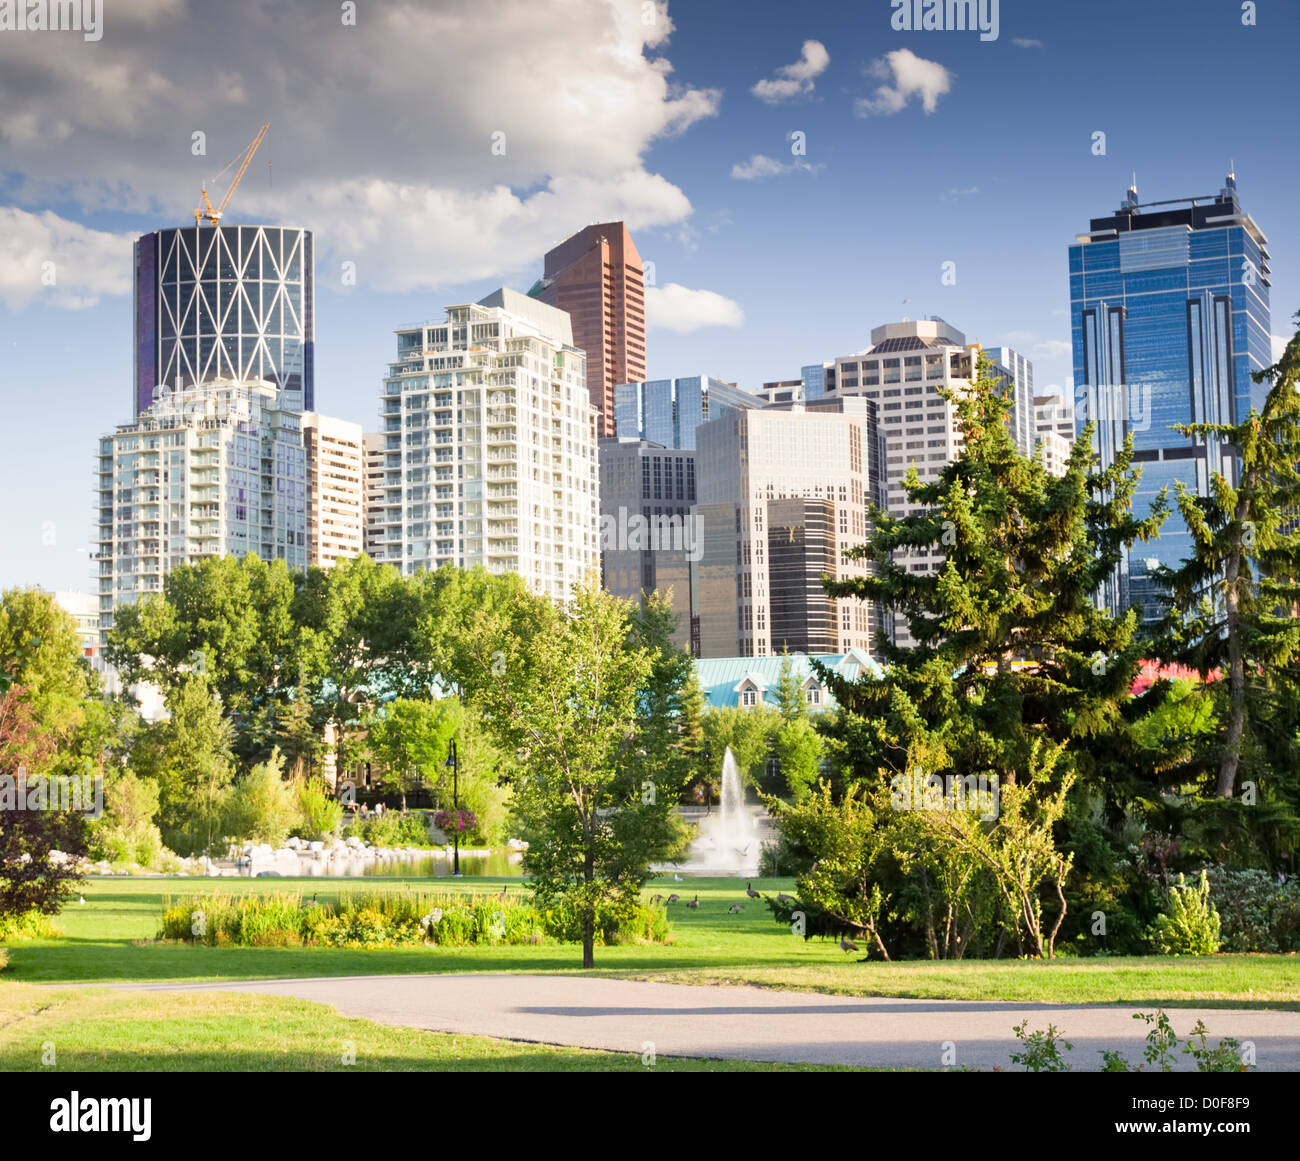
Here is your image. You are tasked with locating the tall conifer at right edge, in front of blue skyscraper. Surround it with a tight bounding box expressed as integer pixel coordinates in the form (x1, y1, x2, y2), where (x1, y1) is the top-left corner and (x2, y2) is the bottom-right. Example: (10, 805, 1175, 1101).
(1157, 323, 1300, 798)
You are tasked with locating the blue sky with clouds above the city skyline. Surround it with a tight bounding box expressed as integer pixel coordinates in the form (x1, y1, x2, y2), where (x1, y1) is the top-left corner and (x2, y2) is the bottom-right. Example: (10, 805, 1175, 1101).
(0, 0, 1300, 592)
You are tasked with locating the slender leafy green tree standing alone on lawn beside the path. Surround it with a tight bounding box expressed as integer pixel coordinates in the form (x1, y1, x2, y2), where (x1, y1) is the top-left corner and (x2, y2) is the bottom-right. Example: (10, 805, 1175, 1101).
(456, 582, 680, 967)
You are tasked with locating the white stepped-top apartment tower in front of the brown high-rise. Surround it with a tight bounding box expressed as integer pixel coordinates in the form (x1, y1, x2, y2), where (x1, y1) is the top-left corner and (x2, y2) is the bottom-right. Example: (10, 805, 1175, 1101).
(380, 290, 599, 599)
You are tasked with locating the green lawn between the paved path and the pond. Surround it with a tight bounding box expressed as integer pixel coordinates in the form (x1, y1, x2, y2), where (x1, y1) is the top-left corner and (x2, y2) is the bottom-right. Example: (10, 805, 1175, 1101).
(4, 876, 1300, 1009)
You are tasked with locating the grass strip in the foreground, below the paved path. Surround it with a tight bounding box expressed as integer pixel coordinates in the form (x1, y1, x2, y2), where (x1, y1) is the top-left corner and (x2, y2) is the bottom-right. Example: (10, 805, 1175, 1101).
(0, 983, 852, 1073)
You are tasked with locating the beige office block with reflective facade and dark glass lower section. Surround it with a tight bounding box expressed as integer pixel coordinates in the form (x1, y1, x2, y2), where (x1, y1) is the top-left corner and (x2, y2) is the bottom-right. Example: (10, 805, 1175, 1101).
(694, 398, 884, 657)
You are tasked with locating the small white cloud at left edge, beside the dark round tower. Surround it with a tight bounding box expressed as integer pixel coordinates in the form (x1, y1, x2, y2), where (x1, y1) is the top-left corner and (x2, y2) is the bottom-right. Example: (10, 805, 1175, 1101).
(0, 205, 133, 311)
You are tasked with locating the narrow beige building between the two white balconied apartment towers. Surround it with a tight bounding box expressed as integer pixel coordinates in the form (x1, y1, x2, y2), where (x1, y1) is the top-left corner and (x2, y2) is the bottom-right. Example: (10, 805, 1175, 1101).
(302, 411, 365, 568)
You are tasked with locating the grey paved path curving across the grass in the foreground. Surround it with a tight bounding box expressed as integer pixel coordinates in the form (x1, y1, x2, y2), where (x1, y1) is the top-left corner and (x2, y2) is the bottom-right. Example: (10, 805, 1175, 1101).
(124, 972, 1300, 1071)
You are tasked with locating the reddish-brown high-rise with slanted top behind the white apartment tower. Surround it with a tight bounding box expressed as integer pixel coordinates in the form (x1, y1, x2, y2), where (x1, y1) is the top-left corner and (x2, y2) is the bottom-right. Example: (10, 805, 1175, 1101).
(529, 222, 646, 436)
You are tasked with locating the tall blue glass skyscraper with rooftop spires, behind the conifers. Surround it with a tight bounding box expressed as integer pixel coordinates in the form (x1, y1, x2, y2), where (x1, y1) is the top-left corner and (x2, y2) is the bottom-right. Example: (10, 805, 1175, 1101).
(1070, 174, 1270, 620)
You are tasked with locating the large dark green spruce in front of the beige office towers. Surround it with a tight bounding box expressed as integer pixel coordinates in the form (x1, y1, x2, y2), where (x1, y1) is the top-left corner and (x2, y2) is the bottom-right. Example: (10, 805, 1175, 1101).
(816, 348, 1164, 783)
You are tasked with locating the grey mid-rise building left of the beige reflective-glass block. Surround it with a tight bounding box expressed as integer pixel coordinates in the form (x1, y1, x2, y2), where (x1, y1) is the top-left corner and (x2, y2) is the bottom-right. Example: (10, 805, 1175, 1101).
(599, 439, 702, 649)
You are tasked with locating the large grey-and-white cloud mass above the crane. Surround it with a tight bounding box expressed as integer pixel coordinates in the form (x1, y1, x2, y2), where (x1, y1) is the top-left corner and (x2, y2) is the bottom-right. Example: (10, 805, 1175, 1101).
(0, 0, 720, 302)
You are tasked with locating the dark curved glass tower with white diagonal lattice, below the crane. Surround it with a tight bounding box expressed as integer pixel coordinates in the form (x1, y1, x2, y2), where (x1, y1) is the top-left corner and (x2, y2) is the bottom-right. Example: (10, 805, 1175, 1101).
(133, 225, 316, 415)
